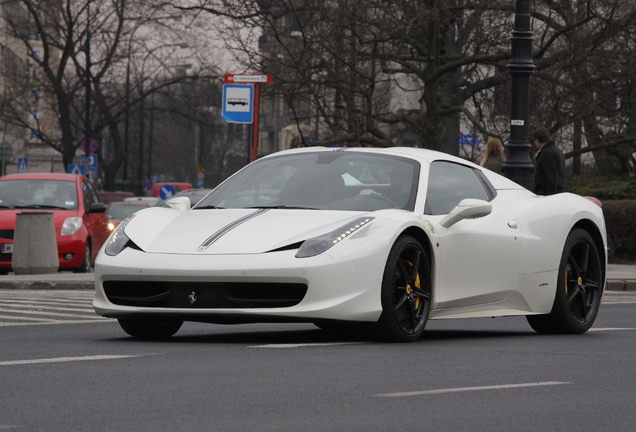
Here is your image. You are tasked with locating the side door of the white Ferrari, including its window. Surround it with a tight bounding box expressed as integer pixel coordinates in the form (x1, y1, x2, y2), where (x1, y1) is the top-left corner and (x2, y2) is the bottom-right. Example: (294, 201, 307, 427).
(425, 161, 523, 308)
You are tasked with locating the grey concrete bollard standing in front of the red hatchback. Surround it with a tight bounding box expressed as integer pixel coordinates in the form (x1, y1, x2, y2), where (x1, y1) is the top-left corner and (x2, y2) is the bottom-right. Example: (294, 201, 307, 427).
(11, 212, 60, 275)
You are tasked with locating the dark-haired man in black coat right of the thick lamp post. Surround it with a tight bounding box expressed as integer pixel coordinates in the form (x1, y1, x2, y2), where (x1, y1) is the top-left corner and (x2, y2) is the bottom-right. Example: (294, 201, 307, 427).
(532, 128, 566, 195)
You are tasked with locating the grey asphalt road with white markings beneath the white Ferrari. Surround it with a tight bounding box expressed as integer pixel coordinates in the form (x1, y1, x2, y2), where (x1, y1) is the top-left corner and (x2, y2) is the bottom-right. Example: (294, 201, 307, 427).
(0, 290, 636, 432)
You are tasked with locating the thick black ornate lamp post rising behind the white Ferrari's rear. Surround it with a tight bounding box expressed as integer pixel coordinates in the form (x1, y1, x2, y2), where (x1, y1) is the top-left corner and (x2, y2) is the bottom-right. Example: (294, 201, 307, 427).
(502, 0, 535, 190)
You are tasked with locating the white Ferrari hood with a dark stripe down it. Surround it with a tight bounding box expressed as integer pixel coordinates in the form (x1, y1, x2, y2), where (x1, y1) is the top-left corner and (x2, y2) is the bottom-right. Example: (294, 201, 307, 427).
(125, 207, 362, 255)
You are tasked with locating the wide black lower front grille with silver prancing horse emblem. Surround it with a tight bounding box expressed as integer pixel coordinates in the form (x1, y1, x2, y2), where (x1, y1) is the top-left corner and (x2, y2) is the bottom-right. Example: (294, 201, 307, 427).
(104, 281, 307, 309)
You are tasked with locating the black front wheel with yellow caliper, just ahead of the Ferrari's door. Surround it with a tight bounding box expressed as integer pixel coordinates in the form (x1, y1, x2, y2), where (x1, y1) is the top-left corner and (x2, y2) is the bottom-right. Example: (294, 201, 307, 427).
(376, 236, 431, 342)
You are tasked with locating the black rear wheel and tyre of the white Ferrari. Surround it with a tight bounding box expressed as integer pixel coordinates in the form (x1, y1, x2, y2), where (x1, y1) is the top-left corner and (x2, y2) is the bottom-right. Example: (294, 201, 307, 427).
(526, 228, 604, 334)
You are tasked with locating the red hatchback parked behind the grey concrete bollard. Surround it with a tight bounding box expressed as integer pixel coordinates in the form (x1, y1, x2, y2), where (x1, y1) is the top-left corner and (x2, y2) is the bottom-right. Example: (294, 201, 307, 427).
(0, 173, 110, 274)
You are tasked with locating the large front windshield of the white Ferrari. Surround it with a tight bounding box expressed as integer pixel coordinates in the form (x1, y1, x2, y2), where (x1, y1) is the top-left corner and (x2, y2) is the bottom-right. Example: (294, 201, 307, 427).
(194, 151, 419, 211)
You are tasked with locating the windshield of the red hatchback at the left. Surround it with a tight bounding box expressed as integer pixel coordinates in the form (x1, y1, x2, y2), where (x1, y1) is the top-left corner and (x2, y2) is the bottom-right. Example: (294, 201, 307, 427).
(0, 179, 77, 210)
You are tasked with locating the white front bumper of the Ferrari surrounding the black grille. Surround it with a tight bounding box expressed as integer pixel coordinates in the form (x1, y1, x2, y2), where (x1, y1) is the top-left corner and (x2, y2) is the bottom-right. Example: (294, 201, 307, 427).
(93, 245, 387, 322)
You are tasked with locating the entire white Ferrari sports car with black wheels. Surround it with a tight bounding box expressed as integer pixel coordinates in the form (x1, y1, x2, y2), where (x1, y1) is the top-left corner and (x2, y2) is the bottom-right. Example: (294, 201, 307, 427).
(93, 147, 607, 341)
